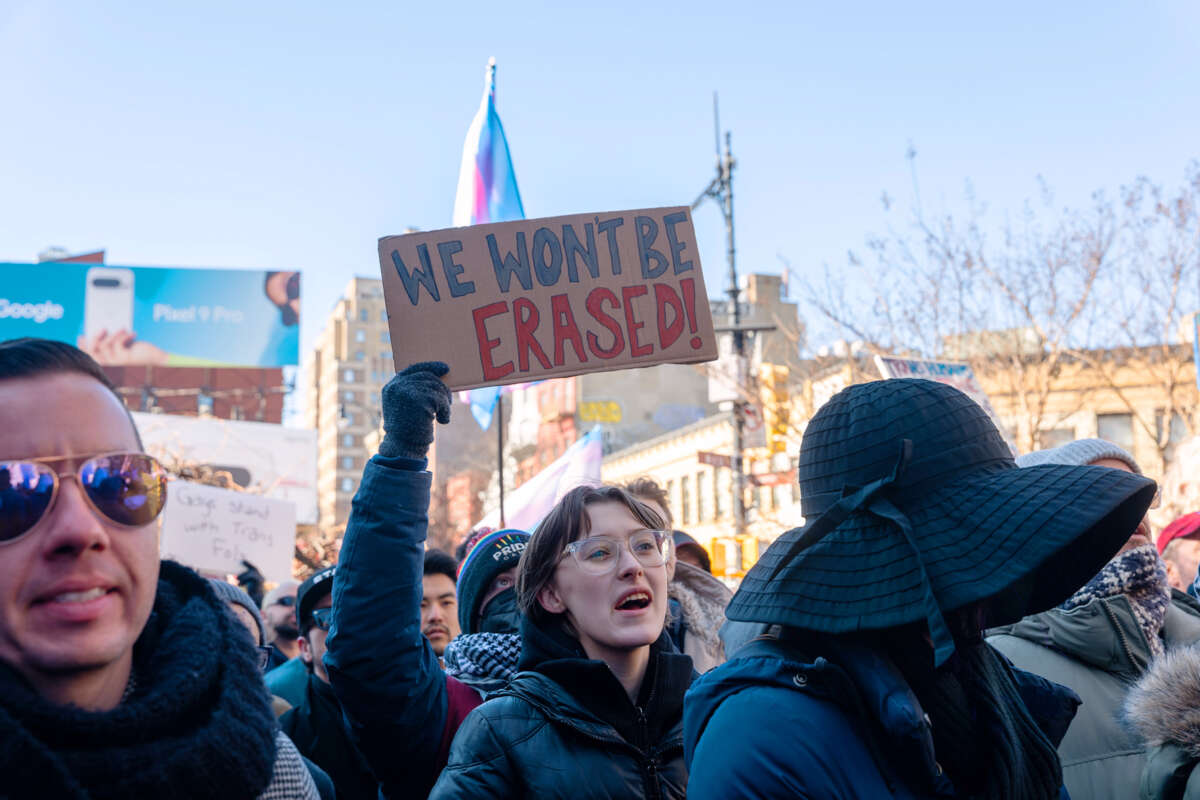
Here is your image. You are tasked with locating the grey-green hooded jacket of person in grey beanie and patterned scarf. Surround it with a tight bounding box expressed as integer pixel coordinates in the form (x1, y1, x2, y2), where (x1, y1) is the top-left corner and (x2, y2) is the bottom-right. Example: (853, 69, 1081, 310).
(988, 591, 1200, 800)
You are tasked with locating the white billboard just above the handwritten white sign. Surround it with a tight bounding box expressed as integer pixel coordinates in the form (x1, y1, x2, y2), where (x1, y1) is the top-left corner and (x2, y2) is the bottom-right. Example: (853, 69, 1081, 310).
(133, 411, 317, 524)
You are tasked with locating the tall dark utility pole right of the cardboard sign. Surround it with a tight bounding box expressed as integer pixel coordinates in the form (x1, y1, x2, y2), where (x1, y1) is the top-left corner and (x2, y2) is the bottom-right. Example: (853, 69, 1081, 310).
(691, 92, 749, 556)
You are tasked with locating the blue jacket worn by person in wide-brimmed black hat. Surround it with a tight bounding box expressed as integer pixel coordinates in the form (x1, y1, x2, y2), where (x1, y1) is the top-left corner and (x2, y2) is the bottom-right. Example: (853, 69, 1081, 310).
(684, 637, 1079, 800)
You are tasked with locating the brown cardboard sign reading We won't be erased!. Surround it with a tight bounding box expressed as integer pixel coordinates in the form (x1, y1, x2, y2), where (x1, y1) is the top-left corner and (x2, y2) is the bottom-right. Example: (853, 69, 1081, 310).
(379, 207, 716, 390)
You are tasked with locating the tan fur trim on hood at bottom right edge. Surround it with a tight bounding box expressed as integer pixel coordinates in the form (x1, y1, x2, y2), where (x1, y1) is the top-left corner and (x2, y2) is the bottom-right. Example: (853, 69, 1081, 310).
(1124, 644, 1200, 758)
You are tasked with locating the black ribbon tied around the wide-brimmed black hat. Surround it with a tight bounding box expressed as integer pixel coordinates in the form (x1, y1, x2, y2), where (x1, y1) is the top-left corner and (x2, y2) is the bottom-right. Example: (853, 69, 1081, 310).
(768, 439, 954, 667)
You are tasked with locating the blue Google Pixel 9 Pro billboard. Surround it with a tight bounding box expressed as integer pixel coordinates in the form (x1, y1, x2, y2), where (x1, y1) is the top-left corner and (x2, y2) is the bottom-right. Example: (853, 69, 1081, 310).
(0, 261, 300, 367)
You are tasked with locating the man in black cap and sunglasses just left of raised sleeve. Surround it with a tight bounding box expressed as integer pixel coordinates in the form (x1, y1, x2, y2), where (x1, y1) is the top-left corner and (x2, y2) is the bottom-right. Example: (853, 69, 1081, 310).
(280, 566, 379, 800)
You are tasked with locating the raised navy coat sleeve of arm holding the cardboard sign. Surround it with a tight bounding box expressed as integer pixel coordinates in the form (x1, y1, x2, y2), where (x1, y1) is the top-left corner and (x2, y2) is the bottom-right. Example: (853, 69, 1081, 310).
(325, 456, 448, 798)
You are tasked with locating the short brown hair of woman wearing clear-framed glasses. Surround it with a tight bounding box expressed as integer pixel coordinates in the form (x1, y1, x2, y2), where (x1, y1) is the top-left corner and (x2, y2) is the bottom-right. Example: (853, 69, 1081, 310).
(517, 486, 666, 624)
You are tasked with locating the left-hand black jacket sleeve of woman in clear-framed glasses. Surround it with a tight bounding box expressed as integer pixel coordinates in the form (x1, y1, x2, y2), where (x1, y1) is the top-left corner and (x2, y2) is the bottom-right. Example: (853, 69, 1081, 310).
(430, 700, 524, 800)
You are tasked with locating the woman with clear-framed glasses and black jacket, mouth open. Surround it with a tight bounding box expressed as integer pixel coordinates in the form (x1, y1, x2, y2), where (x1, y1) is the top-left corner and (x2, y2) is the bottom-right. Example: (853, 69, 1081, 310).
(430, 486, 696, 800)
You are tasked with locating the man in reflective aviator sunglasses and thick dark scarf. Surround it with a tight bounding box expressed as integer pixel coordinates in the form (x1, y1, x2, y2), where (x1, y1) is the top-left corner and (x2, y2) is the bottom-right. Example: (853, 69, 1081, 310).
(0, 339, 317, 800)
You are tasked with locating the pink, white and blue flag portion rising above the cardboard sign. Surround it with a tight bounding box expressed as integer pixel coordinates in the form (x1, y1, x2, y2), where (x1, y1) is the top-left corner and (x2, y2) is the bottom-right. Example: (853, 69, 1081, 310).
(452, 59, 524, 228)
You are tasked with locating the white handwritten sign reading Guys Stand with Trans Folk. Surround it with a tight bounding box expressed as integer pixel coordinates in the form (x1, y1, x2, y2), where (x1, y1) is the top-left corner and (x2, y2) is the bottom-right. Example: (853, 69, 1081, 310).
(161, 481, 296, 581)
